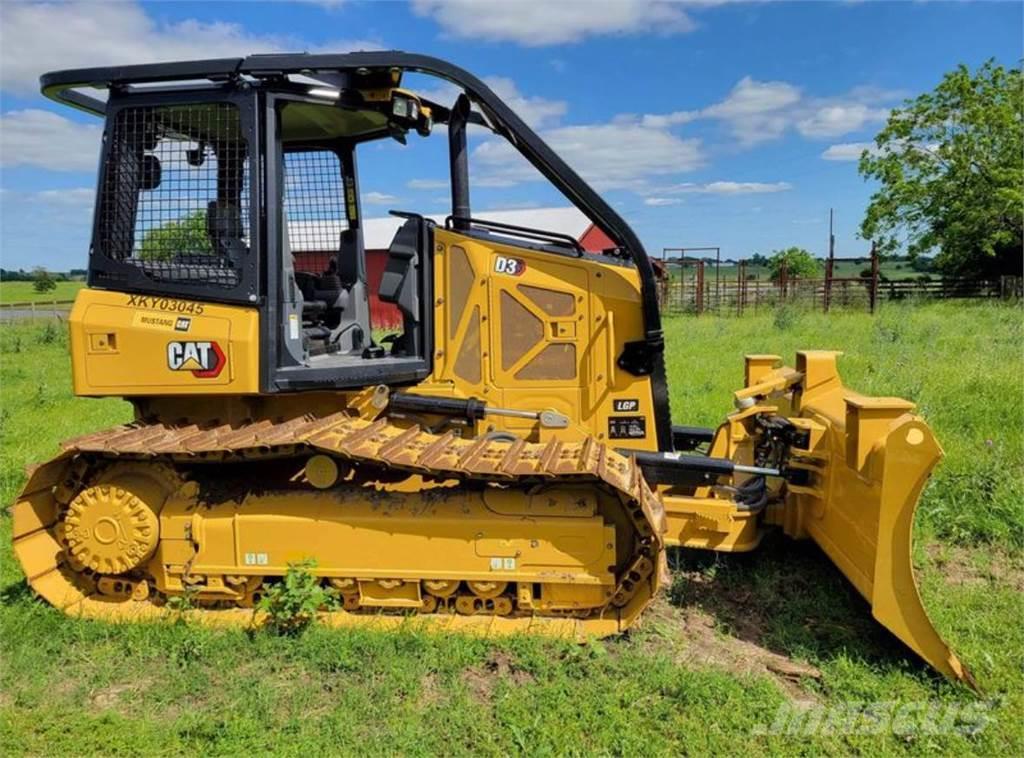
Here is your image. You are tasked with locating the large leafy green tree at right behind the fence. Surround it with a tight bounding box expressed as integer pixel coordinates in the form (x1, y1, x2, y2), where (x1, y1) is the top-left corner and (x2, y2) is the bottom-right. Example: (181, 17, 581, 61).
(860, 59, 1024, 276)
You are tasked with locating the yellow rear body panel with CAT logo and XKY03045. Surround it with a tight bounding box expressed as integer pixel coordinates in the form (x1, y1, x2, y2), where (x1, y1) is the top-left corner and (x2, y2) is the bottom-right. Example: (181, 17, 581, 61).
(69, 289, 259, 396)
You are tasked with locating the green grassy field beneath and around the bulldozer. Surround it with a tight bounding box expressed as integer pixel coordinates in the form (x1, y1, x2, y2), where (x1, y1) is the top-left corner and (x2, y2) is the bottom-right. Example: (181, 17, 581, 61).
(0, 303, 1024, 756)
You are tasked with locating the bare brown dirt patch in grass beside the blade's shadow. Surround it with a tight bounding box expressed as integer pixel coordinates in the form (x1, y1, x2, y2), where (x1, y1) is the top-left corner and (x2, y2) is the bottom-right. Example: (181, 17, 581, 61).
(642, 597, 821, 700)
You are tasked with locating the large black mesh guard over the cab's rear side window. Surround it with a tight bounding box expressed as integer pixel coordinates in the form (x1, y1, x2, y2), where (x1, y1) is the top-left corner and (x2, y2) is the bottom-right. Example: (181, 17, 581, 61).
(97, 102, 250, 288)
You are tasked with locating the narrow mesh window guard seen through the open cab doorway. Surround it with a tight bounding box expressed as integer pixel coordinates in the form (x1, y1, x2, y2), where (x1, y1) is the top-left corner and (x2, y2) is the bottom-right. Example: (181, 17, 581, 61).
(285, 150, 348, 272)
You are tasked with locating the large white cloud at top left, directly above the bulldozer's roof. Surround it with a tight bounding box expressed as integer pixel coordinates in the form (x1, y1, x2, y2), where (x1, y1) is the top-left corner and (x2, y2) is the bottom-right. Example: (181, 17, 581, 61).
(0, 2, 380, 94)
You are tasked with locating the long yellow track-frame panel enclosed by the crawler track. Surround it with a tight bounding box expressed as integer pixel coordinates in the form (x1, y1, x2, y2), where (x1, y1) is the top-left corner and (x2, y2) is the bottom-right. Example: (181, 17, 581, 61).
(151, 488, 615, 609)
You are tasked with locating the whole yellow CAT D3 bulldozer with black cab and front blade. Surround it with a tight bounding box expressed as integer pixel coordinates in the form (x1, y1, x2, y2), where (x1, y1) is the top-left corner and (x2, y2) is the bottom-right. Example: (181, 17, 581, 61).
(13, 52, 970, 681)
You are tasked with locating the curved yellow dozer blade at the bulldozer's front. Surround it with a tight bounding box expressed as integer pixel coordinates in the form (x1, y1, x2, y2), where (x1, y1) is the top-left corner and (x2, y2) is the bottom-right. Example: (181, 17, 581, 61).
(761, 351, 977, 688)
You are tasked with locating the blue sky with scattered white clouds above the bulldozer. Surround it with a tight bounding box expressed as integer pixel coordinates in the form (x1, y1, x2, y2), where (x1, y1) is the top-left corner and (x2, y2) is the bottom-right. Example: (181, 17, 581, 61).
(0, 0, 1024, 270)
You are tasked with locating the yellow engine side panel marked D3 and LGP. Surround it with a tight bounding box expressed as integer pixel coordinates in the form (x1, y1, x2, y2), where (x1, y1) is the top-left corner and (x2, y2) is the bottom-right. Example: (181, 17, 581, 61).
(416, 229, 657, 450)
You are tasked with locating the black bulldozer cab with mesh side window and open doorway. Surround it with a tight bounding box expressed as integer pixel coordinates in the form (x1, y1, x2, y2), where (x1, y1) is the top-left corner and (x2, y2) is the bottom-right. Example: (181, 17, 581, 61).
(90, 71, 444, 389)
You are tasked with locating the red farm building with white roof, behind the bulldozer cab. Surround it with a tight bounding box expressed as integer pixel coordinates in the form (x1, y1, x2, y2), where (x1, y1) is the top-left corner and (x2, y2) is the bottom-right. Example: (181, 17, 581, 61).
(288, 206, 614, 327)
